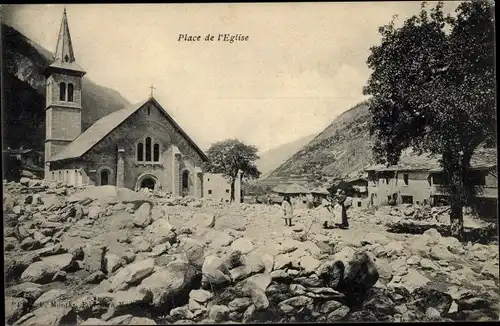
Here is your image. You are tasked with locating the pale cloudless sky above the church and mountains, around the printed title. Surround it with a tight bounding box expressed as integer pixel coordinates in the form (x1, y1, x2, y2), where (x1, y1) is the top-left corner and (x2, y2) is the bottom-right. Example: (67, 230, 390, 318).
(2, 1, 459, 152)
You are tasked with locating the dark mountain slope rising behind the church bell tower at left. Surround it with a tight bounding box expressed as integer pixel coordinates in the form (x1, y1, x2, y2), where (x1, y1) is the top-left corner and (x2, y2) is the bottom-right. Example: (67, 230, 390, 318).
(1, 24, 129, 150)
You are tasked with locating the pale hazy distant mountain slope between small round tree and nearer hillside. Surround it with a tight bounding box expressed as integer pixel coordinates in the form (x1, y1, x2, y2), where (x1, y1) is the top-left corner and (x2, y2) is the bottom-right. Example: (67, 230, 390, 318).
(255, 135, 316, 179)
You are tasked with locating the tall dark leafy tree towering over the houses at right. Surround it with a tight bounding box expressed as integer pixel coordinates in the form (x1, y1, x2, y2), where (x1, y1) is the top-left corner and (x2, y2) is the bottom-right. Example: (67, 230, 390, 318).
(364, 0, 496, 239)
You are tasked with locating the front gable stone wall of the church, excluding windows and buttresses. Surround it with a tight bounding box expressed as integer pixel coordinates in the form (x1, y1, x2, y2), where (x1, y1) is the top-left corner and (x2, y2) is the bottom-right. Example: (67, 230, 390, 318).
(77, 105, 206, 195)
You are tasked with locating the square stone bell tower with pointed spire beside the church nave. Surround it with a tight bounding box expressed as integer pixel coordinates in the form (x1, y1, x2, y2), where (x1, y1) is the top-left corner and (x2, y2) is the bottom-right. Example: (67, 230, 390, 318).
(45, 8, 85, 180)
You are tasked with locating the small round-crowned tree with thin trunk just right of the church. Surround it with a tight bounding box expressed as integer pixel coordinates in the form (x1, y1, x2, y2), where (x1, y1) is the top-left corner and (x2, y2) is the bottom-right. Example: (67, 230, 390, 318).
(207, 139, 260, 201)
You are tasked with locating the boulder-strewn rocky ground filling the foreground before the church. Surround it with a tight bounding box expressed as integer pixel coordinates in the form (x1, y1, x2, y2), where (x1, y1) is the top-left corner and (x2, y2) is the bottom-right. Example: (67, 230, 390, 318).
(4, 178, 499, 325)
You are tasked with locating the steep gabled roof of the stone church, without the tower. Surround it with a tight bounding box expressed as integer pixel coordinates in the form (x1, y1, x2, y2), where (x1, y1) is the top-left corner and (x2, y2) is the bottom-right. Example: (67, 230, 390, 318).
(50, 97, 208, 162)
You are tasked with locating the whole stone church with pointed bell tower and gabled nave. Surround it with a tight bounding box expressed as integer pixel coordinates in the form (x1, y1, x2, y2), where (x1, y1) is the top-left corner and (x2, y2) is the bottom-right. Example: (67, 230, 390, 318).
(45, 9, 223, 198)
